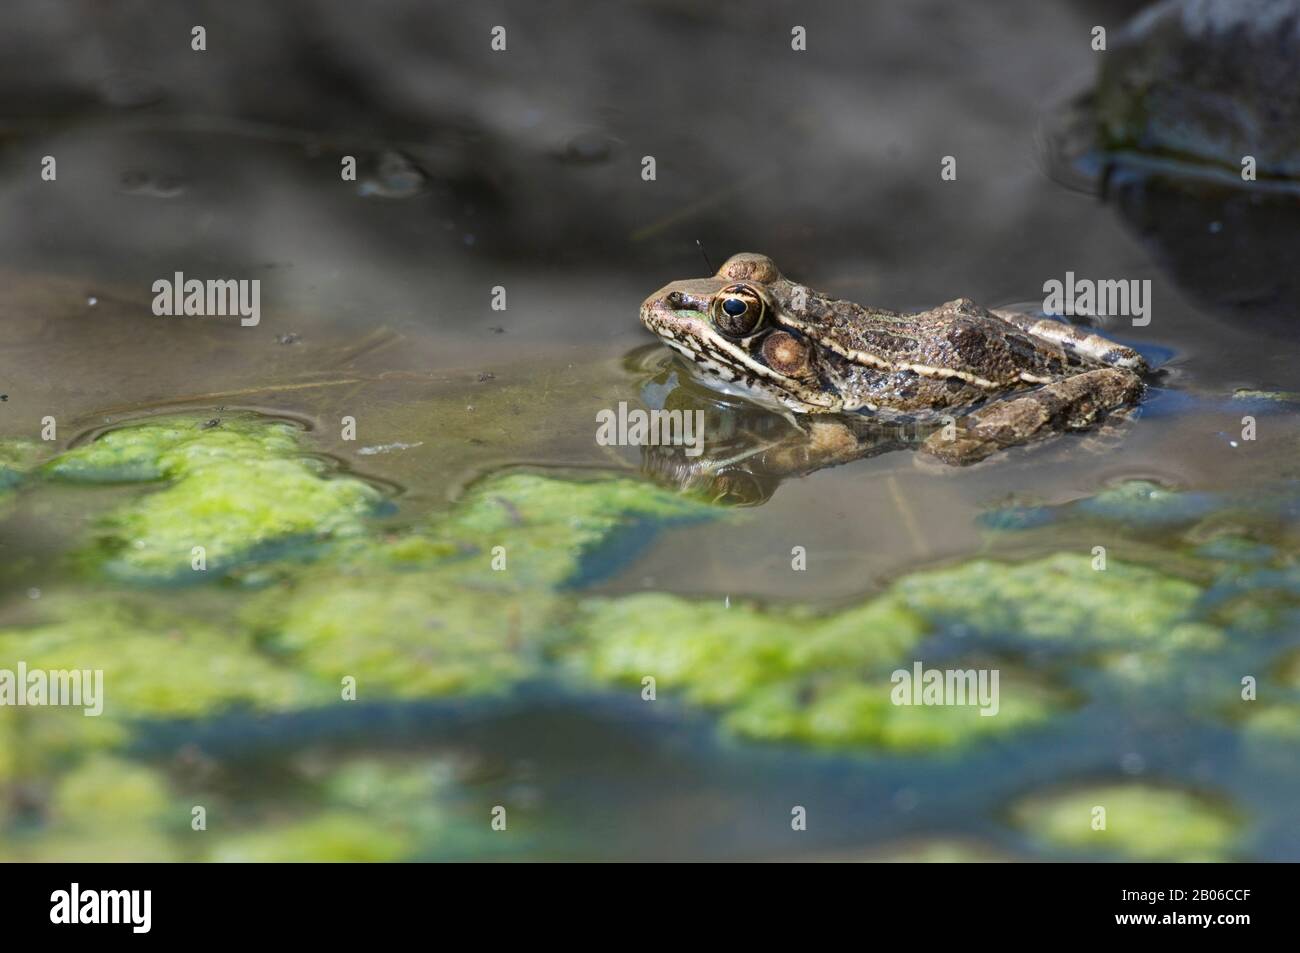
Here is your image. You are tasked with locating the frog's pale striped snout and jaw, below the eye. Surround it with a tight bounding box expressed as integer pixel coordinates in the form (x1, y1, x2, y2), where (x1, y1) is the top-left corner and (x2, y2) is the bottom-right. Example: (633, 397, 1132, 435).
(641, 285, 842, 413)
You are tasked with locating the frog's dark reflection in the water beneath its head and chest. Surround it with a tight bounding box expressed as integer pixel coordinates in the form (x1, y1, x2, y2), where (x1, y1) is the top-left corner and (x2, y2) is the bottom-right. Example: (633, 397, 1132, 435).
(629, 345, 940, 506)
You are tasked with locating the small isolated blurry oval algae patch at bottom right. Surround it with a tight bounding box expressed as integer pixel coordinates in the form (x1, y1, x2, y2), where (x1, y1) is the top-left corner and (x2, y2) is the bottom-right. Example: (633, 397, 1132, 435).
(1011, 783, 1242, 861)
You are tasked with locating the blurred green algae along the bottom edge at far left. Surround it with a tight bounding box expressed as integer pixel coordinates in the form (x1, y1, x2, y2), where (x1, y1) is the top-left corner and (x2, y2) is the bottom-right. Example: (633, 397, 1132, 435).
(0, 753, 499, 862)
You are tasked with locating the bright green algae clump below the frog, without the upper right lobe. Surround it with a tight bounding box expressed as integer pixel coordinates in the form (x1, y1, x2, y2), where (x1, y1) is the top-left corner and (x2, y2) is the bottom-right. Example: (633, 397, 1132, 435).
(562, 594, 1062, 750)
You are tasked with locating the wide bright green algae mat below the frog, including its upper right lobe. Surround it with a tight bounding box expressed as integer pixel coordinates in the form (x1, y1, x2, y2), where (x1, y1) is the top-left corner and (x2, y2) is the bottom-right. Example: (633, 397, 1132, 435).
(558, 553, 1223, 751)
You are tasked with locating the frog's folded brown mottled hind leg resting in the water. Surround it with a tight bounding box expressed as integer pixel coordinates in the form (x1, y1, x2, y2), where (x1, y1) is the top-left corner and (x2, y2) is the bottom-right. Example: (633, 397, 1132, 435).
(920, 368, 1144, 467)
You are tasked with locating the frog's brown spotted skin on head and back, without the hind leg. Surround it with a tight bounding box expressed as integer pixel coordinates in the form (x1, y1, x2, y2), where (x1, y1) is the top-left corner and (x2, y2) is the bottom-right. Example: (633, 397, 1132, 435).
(641, 254, 1144, 417)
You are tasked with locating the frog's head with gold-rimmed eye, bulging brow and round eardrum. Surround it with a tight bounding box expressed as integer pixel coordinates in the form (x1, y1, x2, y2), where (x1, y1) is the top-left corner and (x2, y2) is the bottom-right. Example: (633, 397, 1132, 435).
(641, 254, 841, 413)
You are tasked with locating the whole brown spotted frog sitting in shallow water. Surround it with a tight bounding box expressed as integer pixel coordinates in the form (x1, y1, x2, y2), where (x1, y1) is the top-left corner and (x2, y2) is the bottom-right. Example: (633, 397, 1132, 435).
(641, 252, 1151, 465)
